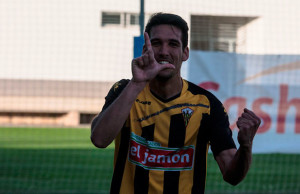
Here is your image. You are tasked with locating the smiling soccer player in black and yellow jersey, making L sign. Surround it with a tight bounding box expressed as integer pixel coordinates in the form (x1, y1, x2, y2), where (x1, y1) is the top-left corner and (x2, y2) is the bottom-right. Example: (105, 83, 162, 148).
(91, 13, 260, 194)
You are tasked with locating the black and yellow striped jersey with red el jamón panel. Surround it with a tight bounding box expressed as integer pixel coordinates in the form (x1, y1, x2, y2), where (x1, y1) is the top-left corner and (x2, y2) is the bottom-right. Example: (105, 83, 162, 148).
(97, 80, 235, 194)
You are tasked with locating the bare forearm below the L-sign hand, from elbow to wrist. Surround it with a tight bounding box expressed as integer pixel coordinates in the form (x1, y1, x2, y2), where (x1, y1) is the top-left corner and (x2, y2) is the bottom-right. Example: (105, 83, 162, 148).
(91, 81, 145, 148)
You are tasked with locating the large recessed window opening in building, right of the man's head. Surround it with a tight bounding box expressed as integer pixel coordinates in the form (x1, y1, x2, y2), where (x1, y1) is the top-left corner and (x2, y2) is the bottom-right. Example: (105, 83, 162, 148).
(190, 15, 255, 52)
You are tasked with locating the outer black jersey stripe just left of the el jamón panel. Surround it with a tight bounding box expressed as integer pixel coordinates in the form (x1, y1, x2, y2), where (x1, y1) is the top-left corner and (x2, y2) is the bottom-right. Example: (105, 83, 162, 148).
(110, 127, 130, 194)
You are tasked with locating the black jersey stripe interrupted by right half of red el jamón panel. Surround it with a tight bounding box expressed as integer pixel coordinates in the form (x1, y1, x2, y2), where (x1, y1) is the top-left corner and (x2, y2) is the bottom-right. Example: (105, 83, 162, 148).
(164, 114, 186, 194)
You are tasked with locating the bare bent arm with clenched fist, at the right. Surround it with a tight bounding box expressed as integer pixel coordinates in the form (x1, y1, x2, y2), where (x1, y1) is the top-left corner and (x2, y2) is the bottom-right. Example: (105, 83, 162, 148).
(215, 109, 261, 185)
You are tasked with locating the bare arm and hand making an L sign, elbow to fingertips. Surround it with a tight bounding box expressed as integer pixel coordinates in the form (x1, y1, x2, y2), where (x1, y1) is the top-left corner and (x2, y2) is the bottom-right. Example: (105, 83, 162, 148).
(91, 33, 175, 148)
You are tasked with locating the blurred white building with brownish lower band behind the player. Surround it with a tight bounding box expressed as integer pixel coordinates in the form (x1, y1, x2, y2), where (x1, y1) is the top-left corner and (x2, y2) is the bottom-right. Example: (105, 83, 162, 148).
(0, 0, 300, 125)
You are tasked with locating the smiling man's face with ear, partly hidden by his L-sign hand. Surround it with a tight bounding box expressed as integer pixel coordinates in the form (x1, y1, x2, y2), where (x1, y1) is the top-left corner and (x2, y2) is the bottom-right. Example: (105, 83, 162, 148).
(150, 25, 189, 79)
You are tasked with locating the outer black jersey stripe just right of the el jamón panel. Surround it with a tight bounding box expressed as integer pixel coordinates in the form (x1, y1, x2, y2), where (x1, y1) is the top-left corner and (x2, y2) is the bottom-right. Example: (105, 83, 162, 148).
(192, 114, 208, 194)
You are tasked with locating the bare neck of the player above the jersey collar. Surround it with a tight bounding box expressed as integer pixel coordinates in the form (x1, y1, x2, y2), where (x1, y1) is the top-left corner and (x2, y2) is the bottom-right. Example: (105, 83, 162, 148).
(149, 77, 183, 99)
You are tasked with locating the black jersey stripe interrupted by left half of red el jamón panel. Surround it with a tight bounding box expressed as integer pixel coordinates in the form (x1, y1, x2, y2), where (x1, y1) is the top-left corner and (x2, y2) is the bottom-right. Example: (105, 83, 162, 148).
(134, 124, 155, 194)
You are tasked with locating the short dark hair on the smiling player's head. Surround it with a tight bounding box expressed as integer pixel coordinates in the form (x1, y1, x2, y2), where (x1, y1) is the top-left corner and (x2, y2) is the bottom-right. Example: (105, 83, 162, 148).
(145, 12, 189, 49)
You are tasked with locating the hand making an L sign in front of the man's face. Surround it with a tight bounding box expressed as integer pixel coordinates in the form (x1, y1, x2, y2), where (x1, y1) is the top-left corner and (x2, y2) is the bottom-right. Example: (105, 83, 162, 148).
(131, 32, 175, 83)
